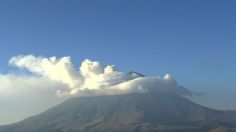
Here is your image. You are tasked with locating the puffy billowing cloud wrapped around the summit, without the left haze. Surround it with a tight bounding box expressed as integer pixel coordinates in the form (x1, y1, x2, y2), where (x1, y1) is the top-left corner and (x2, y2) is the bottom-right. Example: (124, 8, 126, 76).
(9, 55, 192, 96)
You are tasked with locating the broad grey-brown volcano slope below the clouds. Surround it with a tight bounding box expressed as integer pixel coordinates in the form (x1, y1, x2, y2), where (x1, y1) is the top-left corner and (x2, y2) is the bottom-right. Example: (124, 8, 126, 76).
(0, 92, 236, 132)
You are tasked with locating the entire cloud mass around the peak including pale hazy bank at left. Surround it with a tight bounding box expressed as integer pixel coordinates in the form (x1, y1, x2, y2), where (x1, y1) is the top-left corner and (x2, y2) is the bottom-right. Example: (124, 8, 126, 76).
(0, 55, 191, 124)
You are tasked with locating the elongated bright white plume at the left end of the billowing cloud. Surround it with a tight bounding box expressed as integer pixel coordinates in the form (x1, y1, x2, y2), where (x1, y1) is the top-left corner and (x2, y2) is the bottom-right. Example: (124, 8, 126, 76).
(9, 55, 83, 88)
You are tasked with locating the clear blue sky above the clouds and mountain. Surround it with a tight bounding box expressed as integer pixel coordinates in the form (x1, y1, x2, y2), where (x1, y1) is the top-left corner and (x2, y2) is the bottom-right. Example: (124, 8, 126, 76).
(0, 0, 236, 100)
